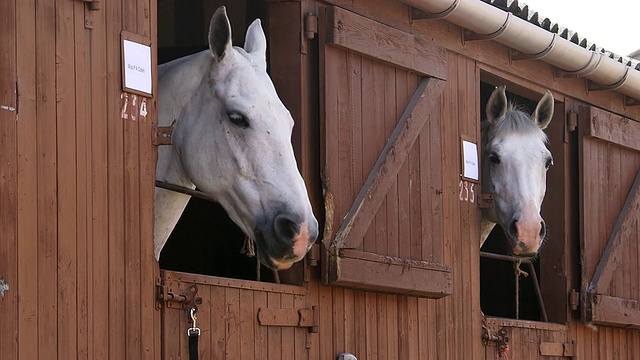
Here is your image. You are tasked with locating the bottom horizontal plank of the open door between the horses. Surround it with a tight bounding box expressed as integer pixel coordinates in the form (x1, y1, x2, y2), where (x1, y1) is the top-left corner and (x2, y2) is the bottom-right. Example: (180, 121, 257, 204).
(330, 250, 453, 298)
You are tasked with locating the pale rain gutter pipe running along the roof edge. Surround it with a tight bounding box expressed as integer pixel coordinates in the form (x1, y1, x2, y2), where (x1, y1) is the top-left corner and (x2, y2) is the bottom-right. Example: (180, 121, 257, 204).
(400, 0, 640, 100)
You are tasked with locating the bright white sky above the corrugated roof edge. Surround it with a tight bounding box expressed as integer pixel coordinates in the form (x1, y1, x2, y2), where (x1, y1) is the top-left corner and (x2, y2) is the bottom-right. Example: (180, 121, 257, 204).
(518, 0, 640, 55)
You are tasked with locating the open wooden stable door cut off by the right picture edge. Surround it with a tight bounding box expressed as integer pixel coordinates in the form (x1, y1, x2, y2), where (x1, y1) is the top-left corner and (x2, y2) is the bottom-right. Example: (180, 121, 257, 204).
(579, 106, 640, 328)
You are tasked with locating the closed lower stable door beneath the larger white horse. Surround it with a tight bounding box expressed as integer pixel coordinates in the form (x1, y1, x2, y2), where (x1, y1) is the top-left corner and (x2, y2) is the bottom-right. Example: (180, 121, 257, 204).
(158, 270, 318, 360)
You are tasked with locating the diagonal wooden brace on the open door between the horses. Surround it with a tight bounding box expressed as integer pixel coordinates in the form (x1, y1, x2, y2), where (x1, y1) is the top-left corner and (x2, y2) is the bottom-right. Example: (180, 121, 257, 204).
(334, 78, 444, 248)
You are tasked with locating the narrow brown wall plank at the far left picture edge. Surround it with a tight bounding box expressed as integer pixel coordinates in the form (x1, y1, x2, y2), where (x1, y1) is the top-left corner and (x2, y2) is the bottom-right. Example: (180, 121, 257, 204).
(0, 0, 20, 360)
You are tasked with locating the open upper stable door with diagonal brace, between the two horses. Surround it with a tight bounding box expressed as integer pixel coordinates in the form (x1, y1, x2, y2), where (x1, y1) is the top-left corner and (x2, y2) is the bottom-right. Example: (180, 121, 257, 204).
(320, 7, 452, 298)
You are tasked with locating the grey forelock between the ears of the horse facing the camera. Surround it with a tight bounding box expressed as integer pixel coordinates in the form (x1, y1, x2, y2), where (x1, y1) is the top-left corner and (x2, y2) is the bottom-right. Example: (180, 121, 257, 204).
(480, 103, 548, 144)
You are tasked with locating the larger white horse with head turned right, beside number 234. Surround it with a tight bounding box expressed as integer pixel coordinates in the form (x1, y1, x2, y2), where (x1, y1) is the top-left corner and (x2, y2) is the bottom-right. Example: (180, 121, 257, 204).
(154, 7, 318, 270)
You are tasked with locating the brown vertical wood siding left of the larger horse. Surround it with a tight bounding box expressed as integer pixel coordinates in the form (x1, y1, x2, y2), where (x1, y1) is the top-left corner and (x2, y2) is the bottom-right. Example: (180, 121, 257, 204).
(0, 0, 159, 359)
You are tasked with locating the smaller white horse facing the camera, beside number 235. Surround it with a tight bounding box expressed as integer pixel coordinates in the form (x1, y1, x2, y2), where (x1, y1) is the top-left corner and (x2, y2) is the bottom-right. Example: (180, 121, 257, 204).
(480, 86, 553, 257)
